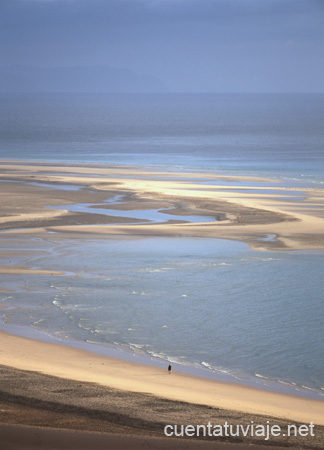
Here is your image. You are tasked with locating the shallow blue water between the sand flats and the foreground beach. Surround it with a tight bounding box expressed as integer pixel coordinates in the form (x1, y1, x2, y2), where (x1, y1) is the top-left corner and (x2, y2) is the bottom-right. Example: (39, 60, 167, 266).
(1, 236, 324, 395)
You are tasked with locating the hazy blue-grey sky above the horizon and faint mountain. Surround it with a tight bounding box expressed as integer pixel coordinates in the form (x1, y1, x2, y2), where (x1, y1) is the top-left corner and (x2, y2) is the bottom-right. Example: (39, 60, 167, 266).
(0, 0, 324, 92)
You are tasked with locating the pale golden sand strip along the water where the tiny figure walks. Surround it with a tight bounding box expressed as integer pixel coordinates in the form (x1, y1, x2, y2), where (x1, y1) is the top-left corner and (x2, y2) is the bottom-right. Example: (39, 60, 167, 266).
(0, 331, 324, 425)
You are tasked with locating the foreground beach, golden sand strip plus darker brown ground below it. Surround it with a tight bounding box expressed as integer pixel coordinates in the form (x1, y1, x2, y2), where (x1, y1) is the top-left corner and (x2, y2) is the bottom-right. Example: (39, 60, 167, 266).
(0, 332, 324, 449)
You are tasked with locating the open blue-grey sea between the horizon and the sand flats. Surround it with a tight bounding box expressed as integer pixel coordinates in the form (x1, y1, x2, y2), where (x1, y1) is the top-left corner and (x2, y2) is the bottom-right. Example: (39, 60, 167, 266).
(0, 94, 324, 185)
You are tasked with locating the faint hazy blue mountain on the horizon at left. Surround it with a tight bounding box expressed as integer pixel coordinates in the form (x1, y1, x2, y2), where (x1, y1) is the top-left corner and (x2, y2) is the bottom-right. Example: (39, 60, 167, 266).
(0, 66, 166, 93)
